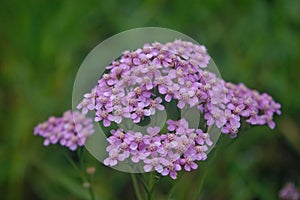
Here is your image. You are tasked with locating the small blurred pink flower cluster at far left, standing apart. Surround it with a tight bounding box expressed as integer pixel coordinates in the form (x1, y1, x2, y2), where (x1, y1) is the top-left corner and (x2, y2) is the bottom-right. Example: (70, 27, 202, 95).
(34, 111, 94, 151)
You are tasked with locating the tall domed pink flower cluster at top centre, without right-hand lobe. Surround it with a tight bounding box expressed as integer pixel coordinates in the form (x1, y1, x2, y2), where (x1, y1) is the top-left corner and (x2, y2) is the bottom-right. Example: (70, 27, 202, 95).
(77, 41, 210, 126)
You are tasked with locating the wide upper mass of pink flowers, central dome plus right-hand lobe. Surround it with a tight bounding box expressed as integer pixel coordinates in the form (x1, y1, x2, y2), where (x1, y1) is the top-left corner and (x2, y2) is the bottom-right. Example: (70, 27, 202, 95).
(77, 40, 280, 137)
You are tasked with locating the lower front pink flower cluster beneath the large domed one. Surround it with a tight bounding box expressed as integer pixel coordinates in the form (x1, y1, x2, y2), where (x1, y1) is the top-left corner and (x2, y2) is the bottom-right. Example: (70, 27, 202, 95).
(104, 119, 212, 179)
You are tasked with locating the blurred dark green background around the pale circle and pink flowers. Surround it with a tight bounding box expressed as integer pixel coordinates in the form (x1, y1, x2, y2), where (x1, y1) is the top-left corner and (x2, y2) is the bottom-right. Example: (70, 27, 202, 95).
(0, 0, 300, 200)
